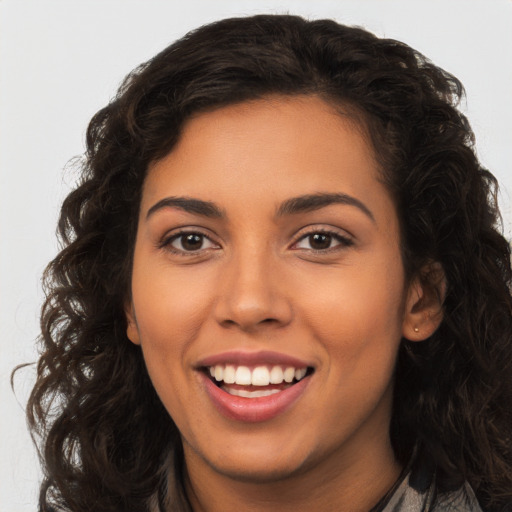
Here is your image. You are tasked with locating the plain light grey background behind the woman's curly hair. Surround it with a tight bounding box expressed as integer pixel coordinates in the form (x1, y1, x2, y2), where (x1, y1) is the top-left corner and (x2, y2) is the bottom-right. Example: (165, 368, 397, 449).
(0, 0, 512, 512)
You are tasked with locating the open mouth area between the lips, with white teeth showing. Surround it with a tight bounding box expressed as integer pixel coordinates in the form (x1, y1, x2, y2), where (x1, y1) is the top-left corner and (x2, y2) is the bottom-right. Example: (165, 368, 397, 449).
(204, 364, 314, 398)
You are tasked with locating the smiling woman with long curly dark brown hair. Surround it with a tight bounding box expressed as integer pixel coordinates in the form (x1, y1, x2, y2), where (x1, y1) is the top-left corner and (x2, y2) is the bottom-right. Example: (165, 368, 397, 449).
(29, 16, 512, 511)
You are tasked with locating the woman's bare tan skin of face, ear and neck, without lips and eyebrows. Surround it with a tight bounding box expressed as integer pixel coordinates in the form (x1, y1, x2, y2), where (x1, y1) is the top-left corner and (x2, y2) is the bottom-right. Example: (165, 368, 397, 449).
(126, 96, 440, 512)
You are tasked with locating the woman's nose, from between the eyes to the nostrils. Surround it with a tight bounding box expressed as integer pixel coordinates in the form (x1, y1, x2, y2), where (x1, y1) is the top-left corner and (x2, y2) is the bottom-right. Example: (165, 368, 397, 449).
(215, 250, 293, 332)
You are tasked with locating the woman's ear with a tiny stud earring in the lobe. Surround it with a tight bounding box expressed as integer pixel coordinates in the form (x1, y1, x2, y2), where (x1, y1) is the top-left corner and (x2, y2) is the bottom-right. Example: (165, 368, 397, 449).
(402, 262, 446, 341)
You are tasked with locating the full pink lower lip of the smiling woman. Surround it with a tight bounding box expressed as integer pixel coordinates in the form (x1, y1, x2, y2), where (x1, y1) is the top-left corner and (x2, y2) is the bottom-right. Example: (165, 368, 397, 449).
(202, 374, 310, 423)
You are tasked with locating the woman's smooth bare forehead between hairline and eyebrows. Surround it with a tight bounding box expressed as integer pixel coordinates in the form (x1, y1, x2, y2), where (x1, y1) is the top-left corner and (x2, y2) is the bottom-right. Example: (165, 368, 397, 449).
(142, 96, 389, 224)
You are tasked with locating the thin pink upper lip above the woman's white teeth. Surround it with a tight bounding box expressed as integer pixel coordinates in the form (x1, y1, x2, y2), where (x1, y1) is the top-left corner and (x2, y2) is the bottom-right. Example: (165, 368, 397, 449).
(197, 350, 313, 368)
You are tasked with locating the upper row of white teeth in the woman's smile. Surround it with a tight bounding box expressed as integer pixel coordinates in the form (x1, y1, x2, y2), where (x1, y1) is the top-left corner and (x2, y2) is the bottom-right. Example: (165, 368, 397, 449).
(208, 364, 307, 386)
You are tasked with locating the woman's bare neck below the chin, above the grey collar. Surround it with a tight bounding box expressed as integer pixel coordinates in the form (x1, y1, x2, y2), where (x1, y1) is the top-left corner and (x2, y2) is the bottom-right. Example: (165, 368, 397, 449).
(185, 440, 402, 512)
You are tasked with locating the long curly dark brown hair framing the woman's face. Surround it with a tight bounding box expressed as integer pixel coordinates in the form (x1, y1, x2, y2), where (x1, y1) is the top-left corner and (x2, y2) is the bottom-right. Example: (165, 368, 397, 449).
(28, 15, 512, 512)
